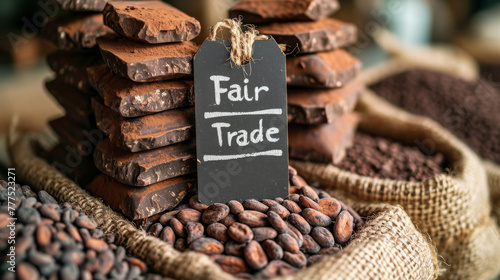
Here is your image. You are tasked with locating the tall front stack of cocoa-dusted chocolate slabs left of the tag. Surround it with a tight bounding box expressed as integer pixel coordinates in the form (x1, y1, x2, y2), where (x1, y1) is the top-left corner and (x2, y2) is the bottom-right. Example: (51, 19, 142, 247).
(86, 1, 200, 222)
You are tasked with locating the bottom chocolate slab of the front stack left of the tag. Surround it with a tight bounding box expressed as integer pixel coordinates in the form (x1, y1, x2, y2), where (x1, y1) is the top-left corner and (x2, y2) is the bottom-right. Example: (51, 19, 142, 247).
(86, 174, 196, 220)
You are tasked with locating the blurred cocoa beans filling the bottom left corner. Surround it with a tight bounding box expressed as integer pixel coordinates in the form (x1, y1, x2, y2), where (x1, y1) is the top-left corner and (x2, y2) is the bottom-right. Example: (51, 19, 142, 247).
(0, 181, 171, 280)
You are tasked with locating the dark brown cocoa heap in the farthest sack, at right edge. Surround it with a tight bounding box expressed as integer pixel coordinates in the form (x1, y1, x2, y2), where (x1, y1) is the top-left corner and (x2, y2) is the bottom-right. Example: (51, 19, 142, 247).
(372, 69, 500, 163)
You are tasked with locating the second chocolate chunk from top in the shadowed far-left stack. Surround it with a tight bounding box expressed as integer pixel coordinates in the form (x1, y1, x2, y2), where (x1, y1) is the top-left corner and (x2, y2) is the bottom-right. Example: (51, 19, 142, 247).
(41, 14, 113, 50)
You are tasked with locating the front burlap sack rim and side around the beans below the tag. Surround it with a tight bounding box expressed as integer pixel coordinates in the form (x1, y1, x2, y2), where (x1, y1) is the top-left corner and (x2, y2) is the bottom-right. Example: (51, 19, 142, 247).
(10, 133, 438, 280)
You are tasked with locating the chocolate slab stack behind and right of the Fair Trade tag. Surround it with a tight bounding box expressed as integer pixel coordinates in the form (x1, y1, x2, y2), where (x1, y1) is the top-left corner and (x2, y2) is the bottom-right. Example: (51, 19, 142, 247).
(229, 0, 362, 163)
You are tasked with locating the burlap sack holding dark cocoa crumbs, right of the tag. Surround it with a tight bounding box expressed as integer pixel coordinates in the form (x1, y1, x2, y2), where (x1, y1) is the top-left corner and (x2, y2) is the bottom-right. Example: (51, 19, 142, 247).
(291, 91, 500, 279)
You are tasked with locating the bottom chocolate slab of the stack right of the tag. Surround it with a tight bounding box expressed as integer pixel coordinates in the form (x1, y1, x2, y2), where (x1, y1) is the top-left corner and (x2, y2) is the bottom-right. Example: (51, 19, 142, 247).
(288, 113, 358, 163)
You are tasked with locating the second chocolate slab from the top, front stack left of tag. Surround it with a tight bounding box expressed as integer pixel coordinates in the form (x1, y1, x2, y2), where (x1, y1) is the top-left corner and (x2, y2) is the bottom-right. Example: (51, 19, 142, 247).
(97, 34, 198, 82)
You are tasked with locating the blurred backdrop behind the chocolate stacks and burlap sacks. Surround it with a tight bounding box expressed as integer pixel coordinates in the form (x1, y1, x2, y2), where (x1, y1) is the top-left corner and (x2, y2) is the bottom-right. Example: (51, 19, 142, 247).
(0, 0, 500, 174)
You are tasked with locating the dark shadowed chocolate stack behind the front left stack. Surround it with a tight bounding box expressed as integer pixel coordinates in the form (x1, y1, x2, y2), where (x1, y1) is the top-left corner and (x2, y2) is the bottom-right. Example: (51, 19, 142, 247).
(41, 0, 113, 184)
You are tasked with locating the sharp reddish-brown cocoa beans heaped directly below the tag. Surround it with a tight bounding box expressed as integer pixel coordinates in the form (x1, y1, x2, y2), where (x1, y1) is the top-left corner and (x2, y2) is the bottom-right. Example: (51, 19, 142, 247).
(148, 168, 363, 279)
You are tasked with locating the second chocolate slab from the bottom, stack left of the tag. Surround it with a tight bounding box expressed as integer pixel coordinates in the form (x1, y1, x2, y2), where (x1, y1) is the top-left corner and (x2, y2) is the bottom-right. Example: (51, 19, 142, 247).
(94, 139, 196, 187)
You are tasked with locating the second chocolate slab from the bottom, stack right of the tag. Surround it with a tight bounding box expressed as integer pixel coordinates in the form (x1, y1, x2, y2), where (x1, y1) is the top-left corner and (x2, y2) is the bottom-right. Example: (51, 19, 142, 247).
(287, 82, 362, 124)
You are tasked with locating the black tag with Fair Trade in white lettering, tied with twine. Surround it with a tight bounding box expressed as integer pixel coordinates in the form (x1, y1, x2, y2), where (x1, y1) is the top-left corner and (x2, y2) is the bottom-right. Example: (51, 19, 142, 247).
(194, 38, 288, 204)
